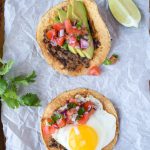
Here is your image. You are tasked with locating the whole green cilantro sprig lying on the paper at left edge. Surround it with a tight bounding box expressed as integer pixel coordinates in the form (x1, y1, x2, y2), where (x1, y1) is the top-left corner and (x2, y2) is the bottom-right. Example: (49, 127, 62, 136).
(0, 59, 40, 109)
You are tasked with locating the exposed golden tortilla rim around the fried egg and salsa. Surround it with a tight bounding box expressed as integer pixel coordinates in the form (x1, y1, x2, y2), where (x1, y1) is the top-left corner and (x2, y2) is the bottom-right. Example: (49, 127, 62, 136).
(41, 88, 119, 150)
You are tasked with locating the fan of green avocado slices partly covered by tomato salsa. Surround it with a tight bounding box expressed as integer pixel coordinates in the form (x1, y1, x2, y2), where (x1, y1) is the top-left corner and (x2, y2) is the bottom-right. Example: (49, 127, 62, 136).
(58, 0, 94, 59)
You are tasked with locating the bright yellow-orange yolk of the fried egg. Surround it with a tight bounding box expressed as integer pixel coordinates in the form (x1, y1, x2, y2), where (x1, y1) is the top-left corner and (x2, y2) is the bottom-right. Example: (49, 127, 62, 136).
(68, 125, 98, 150)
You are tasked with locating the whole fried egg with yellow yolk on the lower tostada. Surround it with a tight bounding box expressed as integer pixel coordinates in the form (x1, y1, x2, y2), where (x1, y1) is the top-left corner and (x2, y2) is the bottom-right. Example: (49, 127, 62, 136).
(52, 95, 116, 150)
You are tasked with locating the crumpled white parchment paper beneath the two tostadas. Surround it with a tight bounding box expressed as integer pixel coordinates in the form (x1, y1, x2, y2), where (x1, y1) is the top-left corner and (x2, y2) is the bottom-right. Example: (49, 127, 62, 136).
(2, 0, 150, 150)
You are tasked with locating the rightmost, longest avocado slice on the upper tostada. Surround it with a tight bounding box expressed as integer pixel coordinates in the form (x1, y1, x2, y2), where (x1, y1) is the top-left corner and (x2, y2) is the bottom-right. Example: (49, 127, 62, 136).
(72, 0, 94, 59)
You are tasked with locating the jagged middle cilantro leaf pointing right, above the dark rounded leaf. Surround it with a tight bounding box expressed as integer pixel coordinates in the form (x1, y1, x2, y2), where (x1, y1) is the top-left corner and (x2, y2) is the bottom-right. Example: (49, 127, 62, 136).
(12, 71, 36, 86)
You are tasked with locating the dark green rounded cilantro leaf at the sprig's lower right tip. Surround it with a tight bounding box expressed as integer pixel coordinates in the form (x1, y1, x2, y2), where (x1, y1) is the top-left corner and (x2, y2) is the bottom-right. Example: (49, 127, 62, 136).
(19, 93, 41, 107)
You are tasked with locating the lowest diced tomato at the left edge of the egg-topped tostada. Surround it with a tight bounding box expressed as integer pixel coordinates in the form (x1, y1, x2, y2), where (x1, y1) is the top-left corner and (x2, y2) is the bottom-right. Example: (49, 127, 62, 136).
(42, 124, 58, 135)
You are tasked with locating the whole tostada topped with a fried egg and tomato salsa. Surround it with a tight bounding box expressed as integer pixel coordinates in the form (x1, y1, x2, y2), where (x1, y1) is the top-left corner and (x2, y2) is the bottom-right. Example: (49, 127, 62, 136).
(41, 88, 119, 150)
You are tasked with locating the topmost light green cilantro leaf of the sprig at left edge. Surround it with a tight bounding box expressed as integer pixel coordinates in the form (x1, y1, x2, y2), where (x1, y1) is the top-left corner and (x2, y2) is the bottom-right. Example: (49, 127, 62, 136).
(0, 60, 14, 76)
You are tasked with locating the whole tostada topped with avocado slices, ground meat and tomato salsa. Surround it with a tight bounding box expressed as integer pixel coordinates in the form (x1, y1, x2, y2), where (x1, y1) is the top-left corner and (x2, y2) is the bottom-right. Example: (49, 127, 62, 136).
(36, 0, 111, 76)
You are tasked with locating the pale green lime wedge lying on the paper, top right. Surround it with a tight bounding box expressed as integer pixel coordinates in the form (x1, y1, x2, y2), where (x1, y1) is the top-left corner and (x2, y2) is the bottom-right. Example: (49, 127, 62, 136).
(108, 0, 141, 27)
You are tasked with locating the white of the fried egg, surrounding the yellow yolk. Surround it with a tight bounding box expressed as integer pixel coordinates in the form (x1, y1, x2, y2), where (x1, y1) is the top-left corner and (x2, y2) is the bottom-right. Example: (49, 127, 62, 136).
(52, 95, 116, 150)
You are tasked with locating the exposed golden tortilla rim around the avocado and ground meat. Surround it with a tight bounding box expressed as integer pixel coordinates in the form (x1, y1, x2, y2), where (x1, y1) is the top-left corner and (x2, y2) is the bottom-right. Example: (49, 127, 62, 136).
(36, 0, 111, 76)
